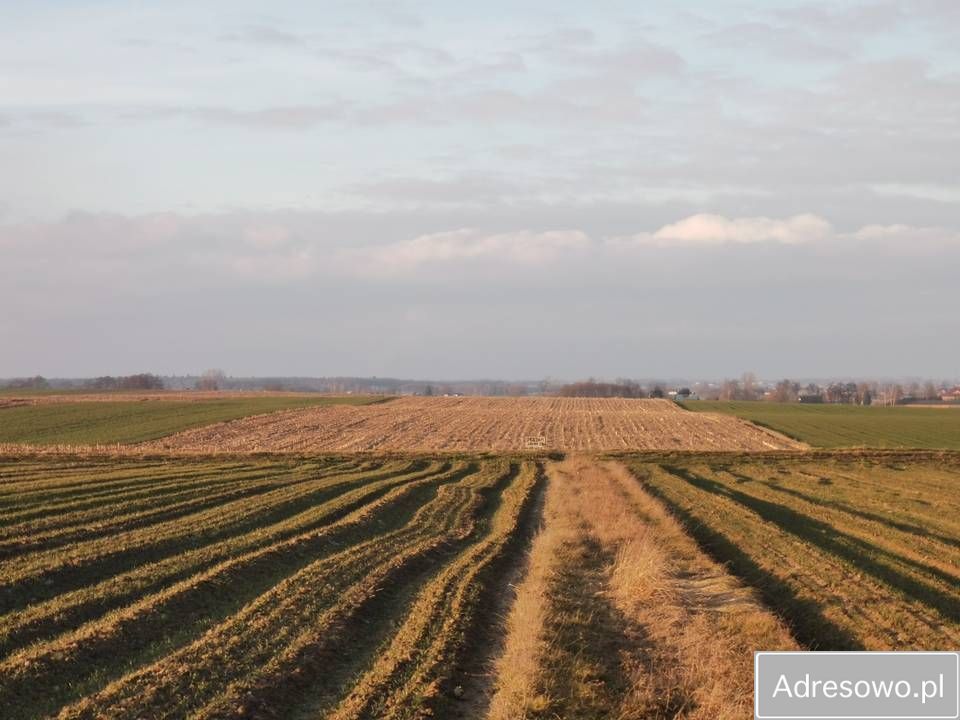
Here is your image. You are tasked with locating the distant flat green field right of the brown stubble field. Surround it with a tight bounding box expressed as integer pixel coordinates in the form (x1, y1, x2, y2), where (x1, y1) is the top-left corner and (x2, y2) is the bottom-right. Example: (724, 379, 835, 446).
(684, 400, 960, 450)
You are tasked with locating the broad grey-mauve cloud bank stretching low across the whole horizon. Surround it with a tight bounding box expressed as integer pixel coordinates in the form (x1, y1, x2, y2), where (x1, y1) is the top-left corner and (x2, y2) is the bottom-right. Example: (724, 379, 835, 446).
(7, 210, 960, 377)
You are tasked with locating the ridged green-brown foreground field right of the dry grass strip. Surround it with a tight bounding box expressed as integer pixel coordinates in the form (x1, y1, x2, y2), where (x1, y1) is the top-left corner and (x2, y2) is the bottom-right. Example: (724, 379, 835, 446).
(629, 455, 960, 650)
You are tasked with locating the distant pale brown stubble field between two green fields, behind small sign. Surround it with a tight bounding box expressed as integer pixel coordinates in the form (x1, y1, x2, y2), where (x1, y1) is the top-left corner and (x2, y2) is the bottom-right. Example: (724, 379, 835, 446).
(137, 397, 805, 453)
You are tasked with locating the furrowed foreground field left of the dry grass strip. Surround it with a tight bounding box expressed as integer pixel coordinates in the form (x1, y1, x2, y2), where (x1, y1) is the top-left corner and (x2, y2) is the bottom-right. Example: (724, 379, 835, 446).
(0, 458, 537, 718)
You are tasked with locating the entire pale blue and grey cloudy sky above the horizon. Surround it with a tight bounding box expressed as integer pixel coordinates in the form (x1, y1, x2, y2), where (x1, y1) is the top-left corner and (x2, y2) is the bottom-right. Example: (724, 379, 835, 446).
(0, 0, 960, 379)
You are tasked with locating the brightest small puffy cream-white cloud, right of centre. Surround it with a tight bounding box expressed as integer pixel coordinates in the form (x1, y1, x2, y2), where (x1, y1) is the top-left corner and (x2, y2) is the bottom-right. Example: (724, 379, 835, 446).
(620, 213, 833, 246)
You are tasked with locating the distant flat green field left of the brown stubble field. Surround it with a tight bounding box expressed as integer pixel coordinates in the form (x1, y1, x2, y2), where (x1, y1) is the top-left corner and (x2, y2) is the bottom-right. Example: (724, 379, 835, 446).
(0, 395, 383, 445)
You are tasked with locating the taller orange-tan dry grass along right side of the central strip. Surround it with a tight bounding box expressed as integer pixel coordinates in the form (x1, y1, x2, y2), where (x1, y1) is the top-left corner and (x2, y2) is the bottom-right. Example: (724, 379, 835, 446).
(580, 463, 796, 720)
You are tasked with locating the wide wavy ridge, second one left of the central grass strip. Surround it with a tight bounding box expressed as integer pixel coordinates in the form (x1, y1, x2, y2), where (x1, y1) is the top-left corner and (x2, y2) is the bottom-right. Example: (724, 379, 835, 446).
(50, 458, 516, 718)
